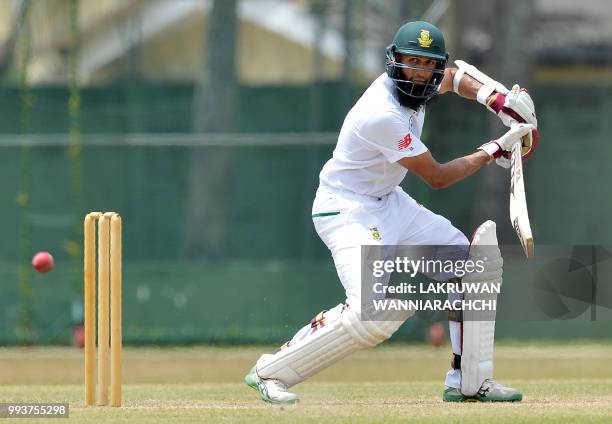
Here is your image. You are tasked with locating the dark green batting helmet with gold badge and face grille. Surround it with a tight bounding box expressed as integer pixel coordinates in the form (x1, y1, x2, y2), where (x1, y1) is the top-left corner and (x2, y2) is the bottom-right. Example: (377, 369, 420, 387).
(385, 21, 448, 101)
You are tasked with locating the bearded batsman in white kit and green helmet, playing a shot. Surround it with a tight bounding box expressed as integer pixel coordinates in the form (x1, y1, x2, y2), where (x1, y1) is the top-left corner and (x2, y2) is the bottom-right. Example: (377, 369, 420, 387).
(245, 21, 537, 403)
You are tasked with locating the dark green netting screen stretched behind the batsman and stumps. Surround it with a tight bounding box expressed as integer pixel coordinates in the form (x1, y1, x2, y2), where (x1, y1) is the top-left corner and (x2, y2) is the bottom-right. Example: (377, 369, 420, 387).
(0, 82, 612, 344)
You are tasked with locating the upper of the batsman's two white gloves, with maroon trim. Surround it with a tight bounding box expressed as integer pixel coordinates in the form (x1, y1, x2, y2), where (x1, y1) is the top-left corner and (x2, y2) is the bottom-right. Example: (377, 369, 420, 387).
(487, 84, 538, 128)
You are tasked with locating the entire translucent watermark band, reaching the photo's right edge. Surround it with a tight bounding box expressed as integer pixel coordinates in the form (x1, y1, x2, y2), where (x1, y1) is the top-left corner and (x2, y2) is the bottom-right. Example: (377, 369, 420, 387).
(361, 245, 612, 321)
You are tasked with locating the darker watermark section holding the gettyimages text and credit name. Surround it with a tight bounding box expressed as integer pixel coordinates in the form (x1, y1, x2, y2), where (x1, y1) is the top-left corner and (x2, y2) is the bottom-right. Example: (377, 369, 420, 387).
(362, 246, 501, 320)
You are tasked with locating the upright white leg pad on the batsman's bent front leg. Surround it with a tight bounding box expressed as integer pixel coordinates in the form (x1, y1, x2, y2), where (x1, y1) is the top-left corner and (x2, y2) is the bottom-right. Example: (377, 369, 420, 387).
(461, 221, 503, 396)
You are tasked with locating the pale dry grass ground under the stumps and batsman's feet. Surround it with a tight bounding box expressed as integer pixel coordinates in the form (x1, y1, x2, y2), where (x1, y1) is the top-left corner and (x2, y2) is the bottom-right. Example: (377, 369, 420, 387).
(0, 342, 612, 424)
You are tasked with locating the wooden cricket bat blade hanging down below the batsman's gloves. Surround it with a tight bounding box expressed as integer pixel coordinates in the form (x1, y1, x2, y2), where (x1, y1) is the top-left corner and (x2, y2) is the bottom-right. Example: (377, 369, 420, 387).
(510, 139, 534, 259)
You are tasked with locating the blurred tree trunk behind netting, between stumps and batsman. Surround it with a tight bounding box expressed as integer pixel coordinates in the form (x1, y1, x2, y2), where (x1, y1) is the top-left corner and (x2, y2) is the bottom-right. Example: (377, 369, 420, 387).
(185, 0, 237, 258)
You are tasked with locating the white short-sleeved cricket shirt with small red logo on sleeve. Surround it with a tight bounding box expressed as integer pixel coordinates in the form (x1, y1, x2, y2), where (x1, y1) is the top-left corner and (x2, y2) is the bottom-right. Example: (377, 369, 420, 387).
(319, 74, 427, 196)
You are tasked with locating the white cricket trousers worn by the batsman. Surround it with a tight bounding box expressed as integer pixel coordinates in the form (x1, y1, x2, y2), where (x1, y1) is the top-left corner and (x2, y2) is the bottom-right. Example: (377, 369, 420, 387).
(312, 186, 470, 309)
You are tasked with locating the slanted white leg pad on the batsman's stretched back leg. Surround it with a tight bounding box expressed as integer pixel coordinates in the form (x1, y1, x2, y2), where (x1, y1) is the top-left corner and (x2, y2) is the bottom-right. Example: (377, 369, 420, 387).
(257, 307, 410, 387)
